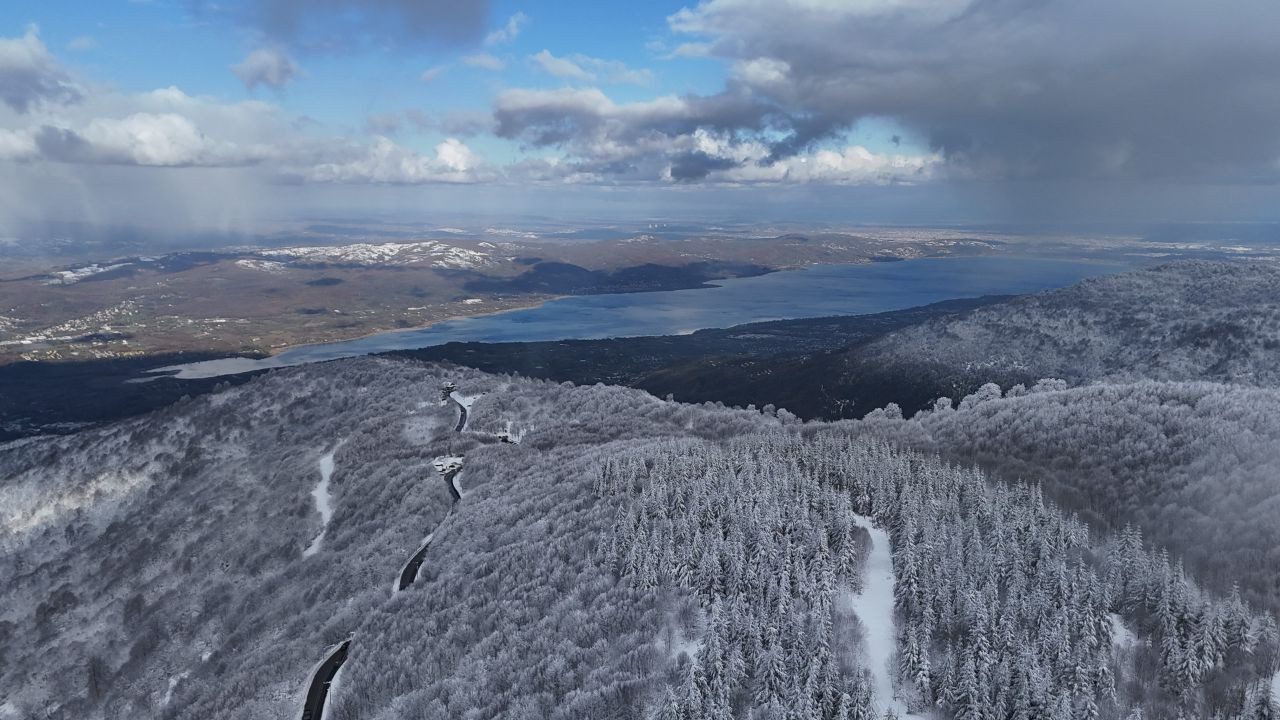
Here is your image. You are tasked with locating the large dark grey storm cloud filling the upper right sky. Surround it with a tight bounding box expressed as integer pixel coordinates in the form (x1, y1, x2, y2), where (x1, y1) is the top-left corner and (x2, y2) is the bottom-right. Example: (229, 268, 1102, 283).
(672, 0, 1280, 178)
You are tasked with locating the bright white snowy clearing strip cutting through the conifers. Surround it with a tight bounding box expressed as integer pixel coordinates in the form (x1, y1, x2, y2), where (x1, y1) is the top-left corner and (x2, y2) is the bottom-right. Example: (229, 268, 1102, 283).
(849, 515, 923, 719)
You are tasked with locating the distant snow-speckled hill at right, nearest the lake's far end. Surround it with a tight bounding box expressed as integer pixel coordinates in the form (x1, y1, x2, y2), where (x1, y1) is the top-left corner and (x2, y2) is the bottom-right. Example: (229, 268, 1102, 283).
(845, 261, 1280, 393)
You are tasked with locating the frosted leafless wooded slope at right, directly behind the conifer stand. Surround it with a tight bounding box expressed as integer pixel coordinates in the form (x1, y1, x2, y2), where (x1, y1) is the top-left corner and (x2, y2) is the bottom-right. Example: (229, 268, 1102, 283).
(863, 380, 1280, 611)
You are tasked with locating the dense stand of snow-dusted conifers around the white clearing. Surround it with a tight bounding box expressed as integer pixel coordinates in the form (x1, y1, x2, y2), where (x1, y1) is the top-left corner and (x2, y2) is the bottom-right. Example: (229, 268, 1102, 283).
(599, 428, 1276, 720)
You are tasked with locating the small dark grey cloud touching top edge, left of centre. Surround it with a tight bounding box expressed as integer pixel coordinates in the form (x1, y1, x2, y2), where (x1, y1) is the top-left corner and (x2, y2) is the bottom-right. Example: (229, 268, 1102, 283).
(193, 0, 492, 50)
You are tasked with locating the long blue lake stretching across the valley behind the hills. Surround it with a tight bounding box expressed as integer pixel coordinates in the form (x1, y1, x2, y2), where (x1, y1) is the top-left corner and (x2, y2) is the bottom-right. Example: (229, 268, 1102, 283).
(156, 256, 1132, 378)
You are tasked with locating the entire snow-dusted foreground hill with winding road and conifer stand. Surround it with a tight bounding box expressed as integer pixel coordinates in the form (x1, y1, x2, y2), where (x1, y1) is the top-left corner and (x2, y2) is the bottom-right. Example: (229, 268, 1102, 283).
(0, 359, 1276, 720)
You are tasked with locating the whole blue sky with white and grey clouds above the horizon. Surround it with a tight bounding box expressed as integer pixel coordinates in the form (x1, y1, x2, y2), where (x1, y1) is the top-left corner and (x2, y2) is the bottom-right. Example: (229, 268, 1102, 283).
(0, 0, 1280, 240)
